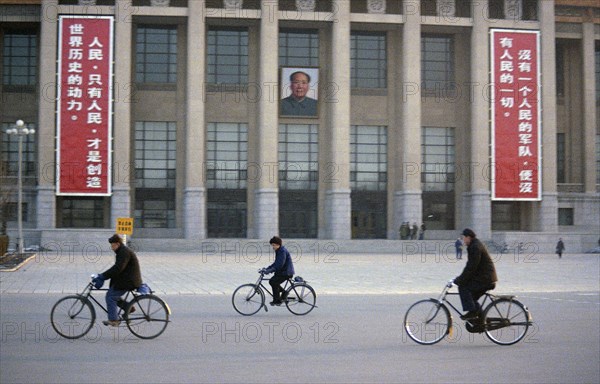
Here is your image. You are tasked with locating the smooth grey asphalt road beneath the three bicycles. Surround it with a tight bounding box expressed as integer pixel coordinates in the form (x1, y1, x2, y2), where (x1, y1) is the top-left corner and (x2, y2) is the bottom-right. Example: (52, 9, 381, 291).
(0, 291, 600, 384)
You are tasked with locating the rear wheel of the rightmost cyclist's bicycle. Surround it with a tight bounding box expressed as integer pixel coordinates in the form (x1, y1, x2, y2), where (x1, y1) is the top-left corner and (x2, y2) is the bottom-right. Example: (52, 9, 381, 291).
(483, 298, 530, 345)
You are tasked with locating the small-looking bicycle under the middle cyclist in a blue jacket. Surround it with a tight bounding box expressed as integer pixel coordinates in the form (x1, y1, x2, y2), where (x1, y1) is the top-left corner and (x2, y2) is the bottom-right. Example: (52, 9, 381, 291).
(231, 270, 317, 316)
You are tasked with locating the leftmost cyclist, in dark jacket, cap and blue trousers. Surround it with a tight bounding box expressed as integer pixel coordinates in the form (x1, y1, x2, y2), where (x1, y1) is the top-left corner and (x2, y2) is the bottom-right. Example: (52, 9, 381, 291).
(94, 234, 142, 326)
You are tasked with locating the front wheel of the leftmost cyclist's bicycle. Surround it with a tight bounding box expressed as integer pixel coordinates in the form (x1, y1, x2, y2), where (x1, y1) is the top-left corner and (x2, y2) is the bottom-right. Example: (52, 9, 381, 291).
(50, 295, 96, 339)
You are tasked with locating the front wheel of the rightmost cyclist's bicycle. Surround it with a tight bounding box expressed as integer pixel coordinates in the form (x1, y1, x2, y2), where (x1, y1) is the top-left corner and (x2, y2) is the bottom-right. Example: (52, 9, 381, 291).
(404, 299, 452, 345)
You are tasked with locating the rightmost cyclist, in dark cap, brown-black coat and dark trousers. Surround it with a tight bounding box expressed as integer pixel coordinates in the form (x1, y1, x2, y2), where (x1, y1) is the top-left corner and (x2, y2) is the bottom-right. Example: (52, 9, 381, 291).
(454, 228, 498, 320)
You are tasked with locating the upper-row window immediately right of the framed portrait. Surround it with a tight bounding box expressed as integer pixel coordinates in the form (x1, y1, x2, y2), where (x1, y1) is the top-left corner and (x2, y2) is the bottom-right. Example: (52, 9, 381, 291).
(350, 32, 387, 88)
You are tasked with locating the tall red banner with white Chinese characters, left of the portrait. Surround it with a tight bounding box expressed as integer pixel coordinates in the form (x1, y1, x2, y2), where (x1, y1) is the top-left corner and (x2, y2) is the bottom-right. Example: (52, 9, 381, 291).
(56, 16, 114, 196)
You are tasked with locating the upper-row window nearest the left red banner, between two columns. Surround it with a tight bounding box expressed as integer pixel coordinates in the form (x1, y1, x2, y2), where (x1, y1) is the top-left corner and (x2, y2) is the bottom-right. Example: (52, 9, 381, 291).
(135, 25, 177, 83)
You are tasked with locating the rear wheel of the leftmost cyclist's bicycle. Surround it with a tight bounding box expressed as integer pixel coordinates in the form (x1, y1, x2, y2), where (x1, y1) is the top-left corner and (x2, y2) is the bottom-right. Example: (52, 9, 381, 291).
(124, 295, 171, 339)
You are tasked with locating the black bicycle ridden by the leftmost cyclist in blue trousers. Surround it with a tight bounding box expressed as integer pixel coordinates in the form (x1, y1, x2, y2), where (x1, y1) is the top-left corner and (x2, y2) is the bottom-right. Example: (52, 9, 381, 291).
(50, 276, 171, 339)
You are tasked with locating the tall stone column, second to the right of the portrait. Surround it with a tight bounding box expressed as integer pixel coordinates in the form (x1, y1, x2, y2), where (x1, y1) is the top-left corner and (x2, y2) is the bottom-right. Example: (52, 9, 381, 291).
(393, 1, 423, 234)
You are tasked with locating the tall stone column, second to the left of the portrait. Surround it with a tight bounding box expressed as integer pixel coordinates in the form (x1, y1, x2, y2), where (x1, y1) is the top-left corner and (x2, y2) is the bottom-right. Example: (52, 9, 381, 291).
(183, 0, 207, 239)
